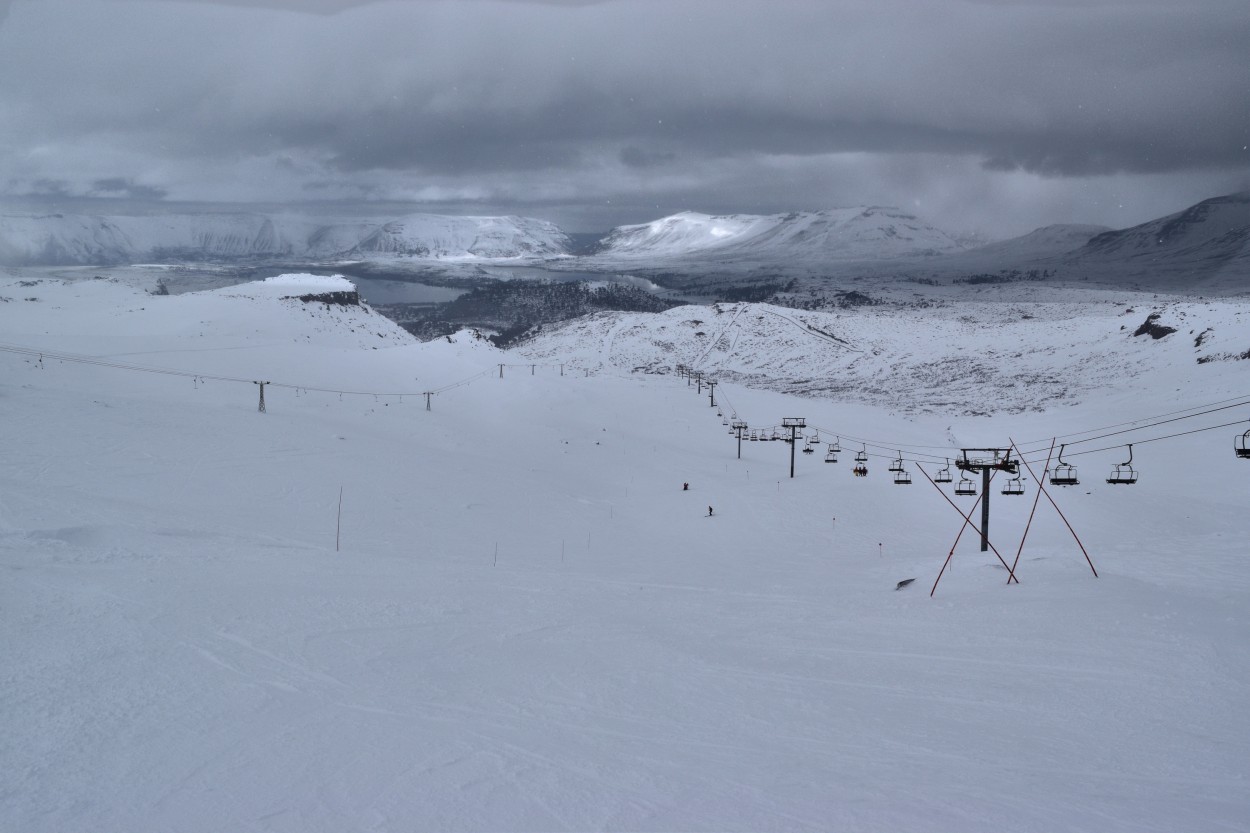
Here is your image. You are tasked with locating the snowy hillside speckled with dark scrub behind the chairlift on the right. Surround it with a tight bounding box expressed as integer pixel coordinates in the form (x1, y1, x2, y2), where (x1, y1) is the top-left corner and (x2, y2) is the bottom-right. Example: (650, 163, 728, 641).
(520, 290, 1250, 414)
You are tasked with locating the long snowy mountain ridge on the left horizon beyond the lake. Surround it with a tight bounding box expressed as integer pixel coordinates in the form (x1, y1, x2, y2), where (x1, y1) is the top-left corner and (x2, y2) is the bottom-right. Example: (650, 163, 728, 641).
(0, 213, 569, 266)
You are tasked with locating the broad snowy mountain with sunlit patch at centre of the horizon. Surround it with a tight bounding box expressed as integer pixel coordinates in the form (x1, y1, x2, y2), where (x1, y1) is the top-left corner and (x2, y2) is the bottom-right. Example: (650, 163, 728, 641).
(580, 206, 961, 263)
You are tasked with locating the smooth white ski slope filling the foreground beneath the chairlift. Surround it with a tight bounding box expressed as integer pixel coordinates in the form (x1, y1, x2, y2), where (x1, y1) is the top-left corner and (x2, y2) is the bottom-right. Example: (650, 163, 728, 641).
(0, 276, 1250, 833)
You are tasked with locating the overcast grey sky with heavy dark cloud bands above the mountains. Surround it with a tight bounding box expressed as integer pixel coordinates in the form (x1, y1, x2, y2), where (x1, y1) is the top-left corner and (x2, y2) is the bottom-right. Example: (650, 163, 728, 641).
(0, 0, 1250, 236)
